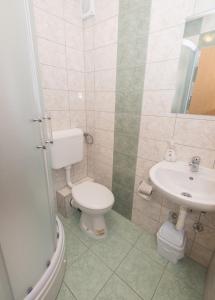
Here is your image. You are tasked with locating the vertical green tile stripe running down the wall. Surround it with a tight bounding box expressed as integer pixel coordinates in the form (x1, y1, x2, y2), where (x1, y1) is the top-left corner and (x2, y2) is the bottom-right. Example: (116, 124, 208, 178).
(112, 0, 151, 219)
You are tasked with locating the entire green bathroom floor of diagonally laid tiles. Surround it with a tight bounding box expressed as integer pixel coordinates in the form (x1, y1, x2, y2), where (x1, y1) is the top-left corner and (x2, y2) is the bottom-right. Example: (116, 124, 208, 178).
(57, 211, 206, 300)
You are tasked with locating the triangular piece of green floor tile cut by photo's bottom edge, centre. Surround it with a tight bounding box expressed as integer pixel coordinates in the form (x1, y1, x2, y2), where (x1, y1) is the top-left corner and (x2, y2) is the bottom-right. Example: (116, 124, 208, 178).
(96, 275, 141, 300)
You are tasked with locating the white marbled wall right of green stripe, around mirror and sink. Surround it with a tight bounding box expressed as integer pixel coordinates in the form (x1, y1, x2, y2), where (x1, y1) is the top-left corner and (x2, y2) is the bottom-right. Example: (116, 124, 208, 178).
(132, 0, 215, 265)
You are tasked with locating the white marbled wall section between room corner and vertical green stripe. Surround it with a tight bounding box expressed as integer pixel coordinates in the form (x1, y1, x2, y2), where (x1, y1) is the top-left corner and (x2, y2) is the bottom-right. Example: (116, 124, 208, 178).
(84, 0, 118, 188)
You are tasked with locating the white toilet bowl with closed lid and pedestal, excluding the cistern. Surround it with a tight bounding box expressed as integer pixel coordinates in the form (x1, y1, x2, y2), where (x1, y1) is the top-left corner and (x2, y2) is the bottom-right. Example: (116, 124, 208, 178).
(72, 181, 114, 239)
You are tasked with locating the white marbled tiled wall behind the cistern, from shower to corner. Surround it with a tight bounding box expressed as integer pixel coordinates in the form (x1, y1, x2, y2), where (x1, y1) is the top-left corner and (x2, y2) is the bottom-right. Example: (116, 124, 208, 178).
(33, 0, 87, 189)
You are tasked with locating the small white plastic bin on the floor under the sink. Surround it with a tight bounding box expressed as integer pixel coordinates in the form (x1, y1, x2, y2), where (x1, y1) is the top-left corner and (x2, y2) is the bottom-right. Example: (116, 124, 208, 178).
(157, 221, 187, 264)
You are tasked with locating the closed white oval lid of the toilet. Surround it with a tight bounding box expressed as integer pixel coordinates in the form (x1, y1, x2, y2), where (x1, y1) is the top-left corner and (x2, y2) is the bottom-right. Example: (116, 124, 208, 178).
(72, 181, 114, 209)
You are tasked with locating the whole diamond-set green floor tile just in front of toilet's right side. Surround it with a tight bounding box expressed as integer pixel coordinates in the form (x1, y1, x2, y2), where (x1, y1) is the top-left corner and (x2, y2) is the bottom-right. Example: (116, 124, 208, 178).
(90, 232, 132, 270)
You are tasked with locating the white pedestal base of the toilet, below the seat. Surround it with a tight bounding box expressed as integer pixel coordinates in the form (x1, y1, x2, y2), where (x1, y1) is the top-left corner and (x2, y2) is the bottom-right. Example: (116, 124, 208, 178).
(80, 211, 107, 239)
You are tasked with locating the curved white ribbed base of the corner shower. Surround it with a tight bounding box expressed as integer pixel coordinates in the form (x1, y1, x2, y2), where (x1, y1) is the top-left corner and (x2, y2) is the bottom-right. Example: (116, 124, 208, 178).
(24, 217, 66, 300)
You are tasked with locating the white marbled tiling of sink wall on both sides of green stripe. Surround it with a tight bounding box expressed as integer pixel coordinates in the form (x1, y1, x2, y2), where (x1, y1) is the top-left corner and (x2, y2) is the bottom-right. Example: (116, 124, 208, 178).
(84, 0, 215, 265)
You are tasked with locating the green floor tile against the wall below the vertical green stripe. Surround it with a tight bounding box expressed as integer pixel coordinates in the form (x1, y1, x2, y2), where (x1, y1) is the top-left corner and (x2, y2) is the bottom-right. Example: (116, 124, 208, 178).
(106, 210, 142, 244)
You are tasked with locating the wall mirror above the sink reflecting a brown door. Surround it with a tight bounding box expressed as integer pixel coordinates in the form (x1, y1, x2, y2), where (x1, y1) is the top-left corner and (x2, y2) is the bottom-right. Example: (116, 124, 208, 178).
(172, 11, 215, 115)
